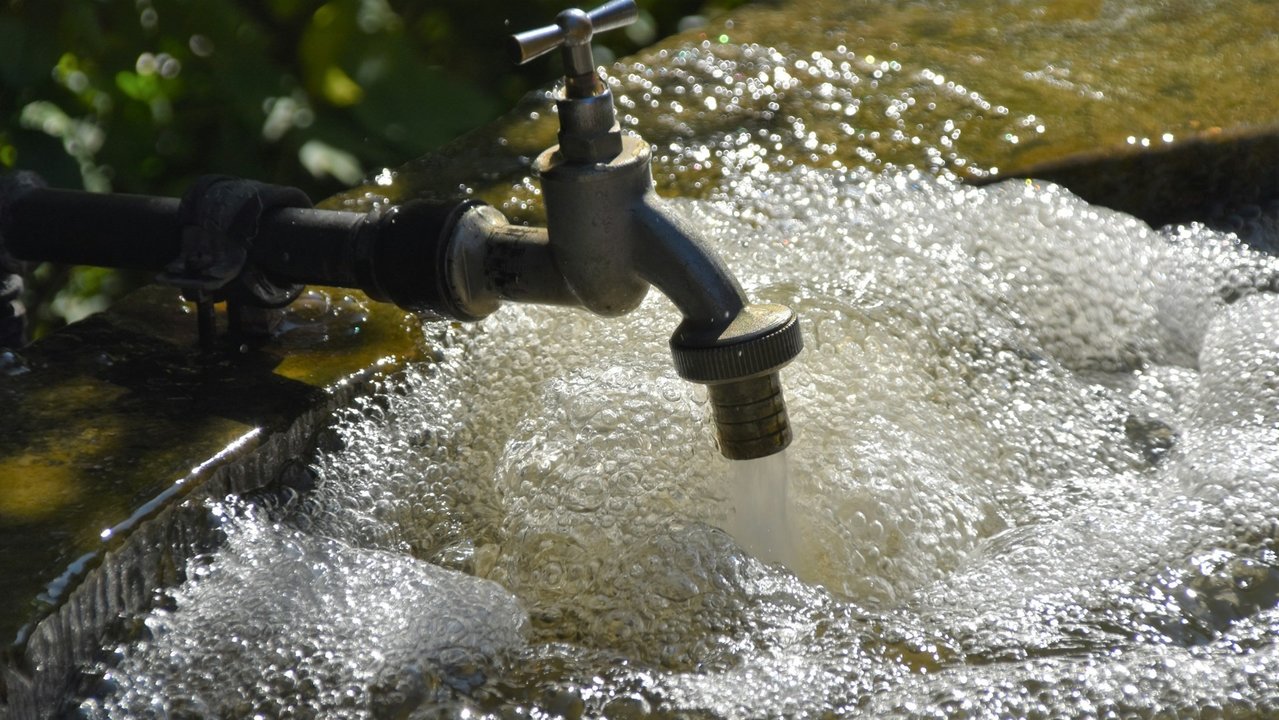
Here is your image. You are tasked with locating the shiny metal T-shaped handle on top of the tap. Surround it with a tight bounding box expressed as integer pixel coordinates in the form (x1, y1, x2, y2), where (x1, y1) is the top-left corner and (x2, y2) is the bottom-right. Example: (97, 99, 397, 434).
(513, 0, 640, 97)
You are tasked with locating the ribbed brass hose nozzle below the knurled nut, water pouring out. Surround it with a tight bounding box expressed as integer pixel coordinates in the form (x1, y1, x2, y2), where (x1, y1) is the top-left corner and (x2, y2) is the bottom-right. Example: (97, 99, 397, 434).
(710, 372, 790, 460)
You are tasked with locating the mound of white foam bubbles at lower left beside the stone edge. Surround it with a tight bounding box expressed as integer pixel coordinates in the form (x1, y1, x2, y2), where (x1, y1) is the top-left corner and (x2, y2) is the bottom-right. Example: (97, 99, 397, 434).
(86, 506, 527, 717)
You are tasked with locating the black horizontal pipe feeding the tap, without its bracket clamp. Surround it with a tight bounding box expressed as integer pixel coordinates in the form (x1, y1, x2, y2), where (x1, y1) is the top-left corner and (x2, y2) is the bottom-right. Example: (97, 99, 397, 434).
(0, 174, 477, 320)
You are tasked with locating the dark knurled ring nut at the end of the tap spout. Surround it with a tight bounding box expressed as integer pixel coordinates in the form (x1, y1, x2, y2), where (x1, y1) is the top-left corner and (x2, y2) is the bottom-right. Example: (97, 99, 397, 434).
(670, 315, 803, 384)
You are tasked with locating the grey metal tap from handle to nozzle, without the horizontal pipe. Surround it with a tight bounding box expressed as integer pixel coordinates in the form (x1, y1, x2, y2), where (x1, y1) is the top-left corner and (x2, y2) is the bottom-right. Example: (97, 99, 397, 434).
(493, 0, 803, 459)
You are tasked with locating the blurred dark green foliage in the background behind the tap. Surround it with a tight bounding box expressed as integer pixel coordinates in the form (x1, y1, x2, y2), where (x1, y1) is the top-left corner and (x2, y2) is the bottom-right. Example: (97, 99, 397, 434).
(0, 0, 744, 334)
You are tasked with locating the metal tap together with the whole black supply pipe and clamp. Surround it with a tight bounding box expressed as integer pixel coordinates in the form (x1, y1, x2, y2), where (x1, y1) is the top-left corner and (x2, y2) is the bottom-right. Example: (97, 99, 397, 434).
(0, 0, 803, 459)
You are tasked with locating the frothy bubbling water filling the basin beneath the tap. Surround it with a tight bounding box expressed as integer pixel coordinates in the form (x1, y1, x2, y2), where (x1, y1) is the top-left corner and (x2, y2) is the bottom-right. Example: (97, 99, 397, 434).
(83, 170, 1279, 717)
